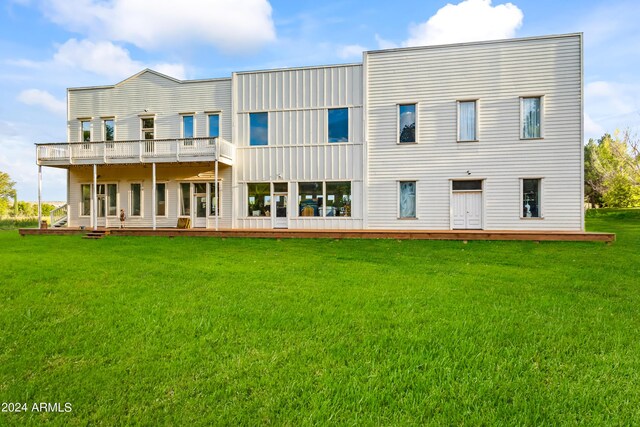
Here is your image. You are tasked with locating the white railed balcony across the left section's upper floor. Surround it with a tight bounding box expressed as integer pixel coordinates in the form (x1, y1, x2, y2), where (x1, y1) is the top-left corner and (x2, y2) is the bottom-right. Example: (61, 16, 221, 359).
(36, 138, 235, 166)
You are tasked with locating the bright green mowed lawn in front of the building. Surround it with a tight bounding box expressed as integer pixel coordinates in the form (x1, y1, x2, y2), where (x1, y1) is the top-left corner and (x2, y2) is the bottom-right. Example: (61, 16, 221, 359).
(0, 211, 640, 426)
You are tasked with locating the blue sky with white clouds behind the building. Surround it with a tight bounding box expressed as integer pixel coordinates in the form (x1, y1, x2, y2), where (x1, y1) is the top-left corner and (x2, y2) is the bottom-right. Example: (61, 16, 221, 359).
(0, 0, 640, 201)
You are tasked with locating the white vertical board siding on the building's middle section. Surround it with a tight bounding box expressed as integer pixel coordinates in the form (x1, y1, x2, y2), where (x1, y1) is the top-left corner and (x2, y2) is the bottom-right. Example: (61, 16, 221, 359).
(234, 65, 364, 229)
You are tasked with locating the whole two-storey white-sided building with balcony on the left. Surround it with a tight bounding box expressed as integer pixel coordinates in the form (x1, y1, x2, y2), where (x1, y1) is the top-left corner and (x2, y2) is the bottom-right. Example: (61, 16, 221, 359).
(37, 34, 584, 231)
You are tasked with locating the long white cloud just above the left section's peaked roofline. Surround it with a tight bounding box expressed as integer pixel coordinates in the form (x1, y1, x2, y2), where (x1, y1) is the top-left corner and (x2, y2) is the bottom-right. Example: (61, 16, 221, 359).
(53, 39, 185, 80)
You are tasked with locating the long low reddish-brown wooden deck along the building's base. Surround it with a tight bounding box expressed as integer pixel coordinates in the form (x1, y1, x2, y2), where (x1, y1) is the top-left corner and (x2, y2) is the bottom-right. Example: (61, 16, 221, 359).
(20, 228, 616, 243)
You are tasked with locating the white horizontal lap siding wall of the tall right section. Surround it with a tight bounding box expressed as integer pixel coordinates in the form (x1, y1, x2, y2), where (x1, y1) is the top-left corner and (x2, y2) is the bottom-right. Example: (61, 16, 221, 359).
(366, 35, 582, 230)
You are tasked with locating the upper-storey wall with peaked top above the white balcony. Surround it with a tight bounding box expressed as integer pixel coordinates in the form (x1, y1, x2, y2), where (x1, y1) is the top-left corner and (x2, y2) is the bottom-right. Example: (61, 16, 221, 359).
(68, 70, 232, 142)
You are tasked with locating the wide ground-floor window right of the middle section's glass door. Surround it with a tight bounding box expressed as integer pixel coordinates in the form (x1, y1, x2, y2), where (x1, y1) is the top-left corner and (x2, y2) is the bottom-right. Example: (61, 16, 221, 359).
(298, 181, 351, 217)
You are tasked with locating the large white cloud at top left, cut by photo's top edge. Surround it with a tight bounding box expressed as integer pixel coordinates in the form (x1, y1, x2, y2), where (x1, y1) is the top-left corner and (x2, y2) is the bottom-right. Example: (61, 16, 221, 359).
(45, 0, 276, 53)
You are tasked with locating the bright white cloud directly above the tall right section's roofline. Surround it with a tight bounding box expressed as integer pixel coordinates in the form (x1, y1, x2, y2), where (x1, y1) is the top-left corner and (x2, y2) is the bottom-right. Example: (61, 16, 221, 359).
(403, 0, 523, 46)
